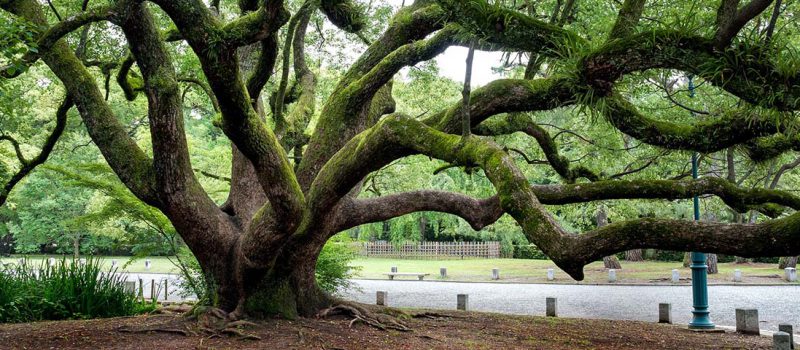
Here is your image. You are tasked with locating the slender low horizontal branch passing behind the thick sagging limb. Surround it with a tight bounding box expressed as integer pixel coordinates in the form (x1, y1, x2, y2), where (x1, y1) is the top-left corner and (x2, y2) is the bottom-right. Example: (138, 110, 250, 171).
(335, 174, 800, 232)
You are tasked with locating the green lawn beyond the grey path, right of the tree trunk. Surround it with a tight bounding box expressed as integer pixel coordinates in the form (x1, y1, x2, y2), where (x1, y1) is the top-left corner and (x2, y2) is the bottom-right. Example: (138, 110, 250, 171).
(351, 258, 787, 284)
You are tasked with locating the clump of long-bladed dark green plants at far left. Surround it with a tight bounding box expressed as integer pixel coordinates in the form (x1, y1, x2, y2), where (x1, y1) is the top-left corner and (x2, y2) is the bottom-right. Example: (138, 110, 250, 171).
(0, 259, 153, 322)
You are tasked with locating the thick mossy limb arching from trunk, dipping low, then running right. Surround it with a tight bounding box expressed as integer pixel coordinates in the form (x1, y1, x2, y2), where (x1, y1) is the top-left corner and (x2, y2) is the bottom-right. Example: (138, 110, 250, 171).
(318, 116, 800, 280)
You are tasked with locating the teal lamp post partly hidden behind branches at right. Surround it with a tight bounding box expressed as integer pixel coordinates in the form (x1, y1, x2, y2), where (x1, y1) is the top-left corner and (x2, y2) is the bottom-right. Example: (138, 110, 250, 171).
(689, 75, 715, 329)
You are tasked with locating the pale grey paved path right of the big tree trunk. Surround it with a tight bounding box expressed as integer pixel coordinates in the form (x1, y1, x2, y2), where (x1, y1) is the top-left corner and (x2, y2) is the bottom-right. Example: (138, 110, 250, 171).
(343, 280, 800, 331)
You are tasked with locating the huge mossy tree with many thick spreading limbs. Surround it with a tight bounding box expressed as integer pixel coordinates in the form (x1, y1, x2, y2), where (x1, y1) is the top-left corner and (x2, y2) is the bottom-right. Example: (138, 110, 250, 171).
(0, 0, 800, 317)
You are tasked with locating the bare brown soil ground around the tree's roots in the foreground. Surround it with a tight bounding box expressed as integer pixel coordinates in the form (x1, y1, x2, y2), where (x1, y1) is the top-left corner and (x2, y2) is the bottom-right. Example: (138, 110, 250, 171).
(0, 311, 772, 350)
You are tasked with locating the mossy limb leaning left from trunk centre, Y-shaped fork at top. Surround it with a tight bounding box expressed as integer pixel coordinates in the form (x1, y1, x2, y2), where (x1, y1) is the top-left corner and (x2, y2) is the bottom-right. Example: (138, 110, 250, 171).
(148, 0, 305, 227)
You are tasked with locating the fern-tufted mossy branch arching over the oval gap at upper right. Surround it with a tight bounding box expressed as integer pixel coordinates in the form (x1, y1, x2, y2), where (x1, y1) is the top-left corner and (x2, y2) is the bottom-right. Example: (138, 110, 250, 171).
(578, 31, 800, 111)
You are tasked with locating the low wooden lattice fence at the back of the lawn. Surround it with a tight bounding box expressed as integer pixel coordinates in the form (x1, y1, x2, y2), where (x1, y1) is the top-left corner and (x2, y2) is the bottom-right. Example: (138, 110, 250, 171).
(354, 241, 500, 259)
